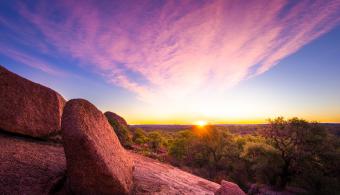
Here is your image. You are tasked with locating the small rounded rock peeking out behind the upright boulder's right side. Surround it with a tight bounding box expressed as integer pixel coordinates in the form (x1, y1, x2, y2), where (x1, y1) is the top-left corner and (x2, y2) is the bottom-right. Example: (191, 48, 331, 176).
(104, 112, 132, 148)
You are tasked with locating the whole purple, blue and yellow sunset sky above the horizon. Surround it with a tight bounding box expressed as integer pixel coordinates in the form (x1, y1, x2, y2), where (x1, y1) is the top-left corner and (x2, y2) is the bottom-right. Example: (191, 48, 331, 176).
(0, 0, 340, 124)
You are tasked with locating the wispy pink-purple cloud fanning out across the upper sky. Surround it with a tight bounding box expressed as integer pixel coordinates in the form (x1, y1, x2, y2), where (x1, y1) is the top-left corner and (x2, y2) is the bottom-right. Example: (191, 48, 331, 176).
(0, 0, 340, 101)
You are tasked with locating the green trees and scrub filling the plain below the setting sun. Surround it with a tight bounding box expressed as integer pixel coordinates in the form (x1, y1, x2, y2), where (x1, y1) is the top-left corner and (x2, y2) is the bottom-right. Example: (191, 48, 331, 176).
(125, 117, 340, 194)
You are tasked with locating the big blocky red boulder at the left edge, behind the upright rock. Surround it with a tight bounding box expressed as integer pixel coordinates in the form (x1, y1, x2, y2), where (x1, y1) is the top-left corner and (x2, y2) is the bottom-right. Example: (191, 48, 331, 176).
(0, 66, 65, 137)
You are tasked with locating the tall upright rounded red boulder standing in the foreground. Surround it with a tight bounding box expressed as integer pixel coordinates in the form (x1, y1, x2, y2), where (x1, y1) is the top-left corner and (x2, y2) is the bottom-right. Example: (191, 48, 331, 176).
(62, 99, 133, 194)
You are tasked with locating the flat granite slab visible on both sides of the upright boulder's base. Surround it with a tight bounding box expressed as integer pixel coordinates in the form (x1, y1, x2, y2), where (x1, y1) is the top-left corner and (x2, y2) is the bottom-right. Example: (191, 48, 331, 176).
(0, 129, 220, 195)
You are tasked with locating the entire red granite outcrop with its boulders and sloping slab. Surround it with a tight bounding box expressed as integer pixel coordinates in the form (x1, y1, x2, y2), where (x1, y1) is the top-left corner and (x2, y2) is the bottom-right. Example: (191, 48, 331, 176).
(0, 66, 244, 195)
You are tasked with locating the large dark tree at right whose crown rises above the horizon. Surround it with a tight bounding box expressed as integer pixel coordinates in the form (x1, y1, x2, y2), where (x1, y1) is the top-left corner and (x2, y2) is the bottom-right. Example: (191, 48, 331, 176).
(262, 117, 335, 189)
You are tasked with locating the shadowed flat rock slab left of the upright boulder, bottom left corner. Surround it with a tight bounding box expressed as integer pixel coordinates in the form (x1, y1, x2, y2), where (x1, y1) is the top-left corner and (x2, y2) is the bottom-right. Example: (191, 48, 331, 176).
(0, 132, 66, 194)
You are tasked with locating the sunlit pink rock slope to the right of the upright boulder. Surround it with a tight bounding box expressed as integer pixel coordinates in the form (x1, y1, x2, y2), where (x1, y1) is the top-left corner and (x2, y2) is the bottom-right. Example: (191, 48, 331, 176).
(130, 153, 220, 195)
